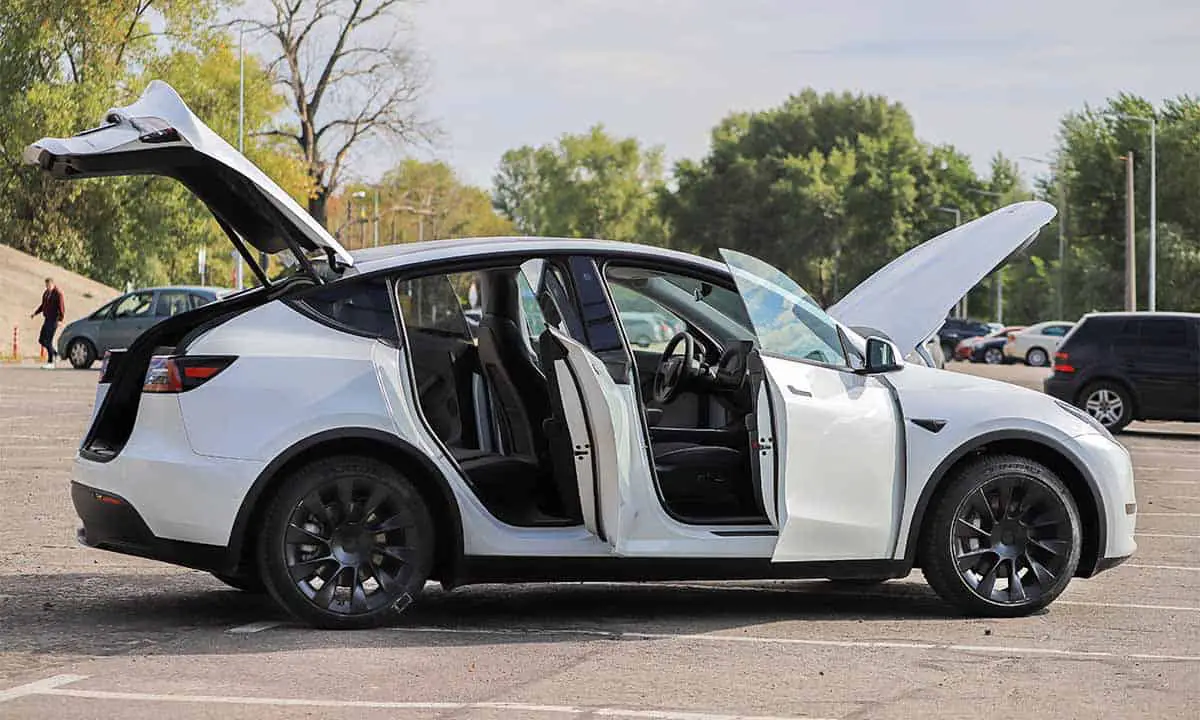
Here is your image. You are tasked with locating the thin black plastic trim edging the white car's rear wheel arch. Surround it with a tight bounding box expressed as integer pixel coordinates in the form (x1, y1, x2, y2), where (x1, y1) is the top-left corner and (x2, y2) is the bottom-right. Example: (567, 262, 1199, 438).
(229, 427, 462, 575)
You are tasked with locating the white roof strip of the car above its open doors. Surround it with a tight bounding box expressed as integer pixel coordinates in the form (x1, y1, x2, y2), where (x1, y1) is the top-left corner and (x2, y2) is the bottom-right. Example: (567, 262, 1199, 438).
(347, 236, 728, 275)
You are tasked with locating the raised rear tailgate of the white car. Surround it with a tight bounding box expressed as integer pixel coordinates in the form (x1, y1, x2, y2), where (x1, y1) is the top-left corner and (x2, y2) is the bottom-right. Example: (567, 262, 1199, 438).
(23, 80, 354, 277)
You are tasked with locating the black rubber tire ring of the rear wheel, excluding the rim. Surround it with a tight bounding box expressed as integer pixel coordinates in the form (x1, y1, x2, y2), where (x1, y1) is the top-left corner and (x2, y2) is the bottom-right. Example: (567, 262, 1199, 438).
(257, 456, 436, 630)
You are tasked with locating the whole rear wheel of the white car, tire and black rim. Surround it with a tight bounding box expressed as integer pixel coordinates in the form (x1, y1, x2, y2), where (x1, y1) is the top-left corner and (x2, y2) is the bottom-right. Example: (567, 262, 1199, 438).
(258, 456, 434, 630)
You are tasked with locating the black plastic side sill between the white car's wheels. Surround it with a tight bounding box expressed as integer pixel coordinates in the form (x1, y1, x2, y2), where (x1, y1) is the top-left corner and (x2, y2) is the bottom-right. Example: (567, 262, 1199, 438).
(458, 556, 911, 584)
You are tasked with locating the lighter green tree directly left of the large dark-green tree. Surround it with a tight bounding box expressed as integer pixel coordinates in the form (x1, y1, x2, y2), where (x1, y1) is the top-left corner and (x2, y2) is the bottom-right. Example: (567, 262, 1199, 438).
(493, 125, 665, 244)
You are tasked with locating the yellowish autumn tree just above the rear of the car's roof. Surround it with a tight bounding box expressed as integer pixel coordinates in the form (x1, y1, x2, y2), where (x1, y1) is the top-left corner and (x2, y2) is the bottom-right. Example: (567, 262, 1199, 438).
(329, 158, 514, 247)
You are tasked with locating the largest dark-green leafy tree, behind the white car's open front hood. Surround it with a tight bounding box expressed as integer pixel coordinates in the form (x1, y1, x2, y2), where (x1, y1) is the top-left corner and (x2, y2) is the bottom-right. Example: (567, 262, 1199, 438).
(662, 90, 980, 304)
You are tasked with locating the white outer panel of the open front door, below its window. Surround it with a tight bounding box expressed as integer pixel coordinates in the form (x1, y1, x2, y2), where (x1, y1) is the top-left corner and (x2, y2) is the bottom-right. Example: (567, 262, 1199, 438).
(763, 358, 902, 562)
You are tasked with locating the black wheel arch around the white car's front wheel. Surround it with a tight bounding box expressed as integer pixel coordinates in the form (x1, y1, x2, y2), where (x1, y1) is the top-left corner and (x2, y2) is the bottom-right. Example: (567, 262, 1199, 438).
(904, 430, 1108, 577)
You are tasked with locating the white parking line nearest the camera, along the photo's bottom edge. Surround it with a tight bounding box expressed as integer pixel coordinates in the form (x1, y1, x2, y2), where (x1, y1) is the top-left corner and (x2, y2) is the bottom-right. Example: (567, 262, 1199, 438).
(0, 676, 820, 720)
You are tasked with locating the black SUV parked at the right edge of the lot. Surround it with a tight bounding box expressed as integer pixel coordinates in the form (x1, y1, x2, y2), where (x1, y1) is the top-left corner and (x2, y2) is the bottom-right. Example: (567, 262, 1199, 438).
(1045, 312, 1200, 432)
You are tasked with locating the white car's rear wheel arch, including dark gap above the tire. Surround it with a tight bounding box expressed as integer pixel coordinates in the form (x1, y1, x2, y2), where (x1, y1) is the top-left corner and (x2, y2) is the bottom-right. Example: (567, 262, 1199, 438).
(229, 427, 462, 582)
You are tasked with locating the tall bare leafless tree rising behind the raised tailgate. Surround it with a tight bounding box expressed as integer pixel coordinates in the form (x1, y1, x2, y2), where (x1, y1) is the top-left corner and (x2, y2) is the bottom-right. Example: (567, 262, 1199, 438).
(246, 0, 430, 223)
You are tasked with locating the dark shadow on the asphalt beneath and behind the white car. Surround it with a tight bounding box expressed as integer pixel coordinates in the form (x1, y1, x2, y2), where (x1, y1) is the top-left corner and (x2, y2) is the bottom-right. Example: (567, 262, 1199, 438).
(0, 572, 956, 655)
